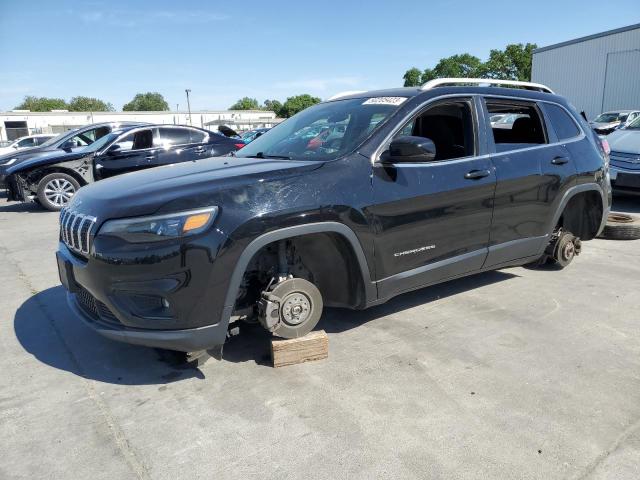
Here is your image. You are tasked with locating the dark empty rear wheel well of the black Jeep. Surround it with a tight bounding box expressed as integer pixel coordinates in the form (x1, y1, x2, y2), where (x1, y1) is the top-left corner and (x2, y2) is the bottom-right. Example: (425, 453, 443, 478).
(558, 190, 603, 240)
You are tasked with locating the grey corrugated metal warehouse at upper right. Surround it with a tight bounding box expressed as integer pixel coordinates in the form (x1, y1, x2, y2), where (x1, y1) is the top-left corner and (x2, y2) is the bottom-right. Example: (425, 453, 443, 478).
(531, 24, 640, 120)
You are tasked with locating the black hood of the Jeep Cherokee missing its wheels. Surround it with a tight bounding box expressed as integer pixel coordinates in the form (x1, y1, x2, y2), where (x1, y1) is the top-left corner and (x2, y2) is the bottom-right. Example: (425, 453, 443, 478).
(70, 157, 323, 220)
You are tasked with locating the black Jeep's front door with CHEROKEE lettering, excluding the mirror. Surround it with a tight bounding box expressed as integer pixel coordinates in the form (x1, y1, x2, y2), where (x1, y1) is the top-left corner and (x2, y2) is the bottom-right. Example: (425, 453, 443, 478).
(368, 97, 496, 298)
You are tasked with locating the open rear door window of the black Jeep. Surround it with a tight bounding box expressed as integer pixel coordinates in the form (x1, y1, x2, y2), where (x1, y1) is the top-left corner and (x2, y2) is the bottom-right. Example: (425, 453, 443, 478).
(486, 100, 547, 148)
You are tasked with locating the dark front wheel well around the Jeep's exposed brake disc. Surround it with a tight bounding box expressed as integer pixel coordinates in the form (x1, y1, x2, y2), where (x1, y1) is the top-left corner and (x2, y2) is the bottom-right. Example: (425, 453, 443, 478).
(236, 232, 365, 310)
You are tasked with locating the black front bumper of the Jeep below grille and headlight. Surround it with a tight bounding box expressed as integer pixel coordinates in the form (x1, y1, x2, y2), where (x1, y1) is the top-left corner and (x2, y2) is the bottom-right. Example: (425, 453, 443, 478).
(56, 230, 228, 352)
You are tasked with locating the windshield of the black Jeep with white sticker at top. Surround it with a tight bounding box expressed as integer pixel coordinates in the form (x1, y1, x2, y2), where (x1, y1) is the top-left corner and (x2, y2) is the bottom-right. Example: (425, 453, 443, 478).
(236, 97, 406, 161)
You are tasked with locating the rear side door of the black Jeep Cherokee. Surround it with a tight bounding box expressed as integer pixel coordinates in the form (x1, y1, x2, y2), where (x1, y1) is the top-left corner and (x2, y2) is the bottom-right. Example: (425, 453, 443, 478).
(484, 97, 576, 267)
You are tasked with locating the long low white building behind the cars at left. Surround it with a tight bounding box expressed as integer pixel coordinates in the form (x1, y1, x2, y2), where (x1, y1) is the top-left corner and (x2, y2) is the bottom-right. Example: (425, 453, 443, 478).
(0, 110, 280, 140)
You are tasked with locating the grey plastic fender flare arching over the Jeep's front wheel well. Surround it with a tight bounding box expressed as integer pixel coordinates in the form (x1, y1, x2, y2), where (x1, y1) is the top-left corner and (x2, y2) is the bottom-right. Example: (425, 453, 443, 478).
(221, 222, 377, 323)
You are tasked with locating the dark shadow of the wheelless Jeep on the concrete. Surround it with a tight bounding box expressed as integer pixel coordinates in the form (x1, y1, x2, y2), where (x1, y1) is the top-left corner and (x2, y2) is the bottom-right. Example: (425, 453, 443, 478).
(14, 271, 516, 385)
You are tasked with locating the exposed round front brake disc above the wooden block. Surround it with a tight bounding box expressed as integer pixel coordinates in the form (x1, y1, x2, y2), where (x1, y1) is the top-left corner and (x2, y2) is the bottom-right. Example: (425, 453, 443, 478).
(271, 278, 323, 338)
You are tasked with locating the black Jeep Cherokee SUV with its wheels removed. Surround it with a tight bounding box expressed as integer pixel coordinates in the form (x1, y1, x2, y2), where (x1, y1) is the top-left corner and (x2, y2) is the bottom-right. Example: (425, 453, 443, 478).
(57, 79, 611, 352)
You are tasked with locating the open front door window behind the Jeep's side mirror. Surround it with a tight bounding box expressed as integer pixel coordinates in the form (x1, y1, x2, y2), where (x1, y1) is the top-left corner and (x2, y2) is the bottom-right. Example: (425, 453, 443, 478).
(395, 99, 476, 161)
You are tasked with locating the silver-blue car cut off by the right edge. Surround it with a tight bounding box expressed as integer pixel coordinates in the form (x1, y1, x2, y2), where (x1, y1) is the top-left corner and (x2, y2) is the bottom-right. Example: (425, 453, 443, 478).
(607, 117, 640, 193)
